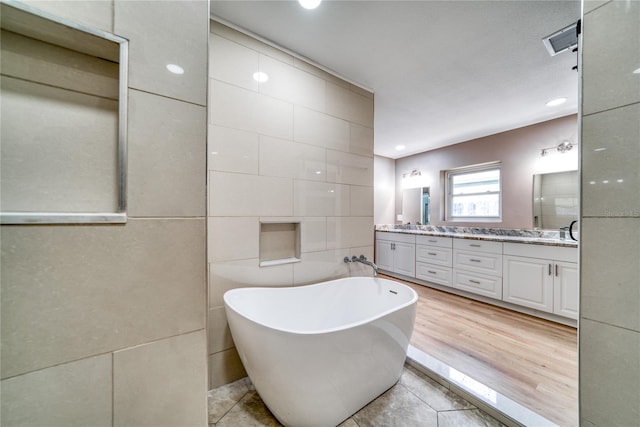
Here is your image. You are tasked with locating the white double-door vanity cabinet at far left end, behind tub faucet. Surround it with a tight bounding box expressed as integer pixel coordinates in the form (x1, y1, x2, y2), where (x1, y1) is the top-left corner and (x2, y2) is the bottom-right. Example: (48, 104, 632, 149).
(375, 231, 416, 277)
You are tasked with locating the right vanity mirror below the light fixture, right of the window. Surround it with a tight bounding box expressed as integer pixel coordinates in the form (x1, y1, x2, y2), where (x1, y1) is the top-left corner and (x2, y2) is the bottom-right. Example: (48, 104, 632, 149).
(533, 171, 579, 230)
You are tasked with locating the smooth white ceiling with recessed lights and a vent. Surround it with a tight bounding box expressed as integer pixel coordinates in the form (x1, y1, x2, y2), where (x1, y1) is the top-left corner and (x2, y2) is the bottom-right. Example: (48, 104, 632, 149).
(211, 0, 580, 158)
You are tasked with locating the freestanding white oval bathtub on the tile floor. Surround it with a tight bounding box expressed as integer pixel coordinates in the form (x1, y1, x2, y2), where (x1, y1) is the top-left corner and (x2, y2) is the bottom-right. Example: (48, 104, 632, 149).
(224, 277, 418, 427)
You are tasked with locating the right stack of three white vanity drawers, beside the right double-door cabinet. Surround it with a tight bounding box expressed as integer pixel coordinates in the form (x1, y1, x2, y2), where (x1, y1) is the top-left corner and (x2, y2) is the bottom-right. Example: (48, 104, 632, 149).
(452, 239, 502, 299)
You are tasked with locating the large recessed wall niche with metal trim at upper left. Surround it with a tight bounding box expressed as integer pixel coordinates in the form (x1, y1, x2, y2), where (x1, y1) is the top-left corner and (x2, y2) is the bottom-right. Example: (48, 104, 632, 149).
(0, 0, 128, 224)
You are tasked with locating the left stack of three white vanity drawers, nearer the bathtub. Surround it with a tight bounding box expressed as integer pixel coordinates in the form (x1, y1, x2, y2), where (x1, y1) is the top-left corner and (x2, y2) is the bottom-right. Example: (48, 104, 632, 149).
(416, 236, 453, 286)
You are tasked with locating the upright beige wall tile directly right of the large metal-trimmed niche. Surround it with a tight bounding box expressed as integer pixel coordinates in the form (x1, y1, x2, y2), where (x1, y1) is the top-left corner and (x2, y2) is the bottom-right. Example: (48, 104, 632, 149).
(127, 90, 207, 217)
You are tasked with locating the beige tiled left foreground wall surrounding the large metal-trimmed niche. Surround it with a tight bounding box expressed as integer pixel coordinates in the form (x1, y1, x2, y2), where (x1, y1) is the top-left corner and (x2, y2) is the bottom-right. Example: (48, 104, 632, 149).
(0, 0, 209, 426)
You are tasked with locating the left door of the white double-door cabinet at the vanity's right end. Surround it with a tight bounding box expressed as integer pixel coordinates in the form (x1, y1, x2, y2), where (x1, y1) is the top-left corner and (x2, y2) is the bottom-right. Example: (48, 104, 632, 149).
(502, 255, 554, 313)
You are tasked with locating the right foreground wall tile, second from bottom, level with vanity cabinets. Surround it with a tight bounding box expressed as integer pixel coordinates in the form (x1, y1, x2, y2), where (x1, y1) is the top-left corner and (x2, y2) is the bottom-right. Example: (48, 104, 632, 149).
(580, 218, 640, 331)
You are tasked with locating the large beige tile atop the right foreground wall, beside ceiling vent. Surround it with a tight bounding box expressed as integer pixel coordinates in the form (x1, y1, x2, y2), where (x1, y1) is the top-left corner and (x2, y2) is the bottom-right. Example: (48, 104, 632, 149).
(582, 1, 640, 115)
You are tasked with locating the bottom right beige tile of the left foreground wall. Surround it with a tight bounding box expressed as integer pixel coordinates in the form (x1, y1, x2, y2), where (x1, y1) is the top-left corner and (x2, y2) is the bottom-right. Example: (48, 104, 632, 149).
(113, 330, 207, 427)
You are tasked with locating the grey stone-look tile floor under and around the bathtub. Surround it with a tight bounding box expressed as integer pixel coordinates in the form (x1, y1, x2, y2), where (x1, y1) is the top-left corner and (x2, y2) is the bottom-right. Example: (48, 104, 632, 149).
(209, 365, 504, 427)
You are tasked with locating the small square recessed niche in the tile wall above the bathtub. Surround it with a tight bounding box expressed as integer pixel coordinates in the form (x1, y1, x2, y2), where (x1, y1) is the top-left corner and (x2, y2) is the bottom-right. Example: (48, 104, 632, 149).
(260, 222, 300, 267)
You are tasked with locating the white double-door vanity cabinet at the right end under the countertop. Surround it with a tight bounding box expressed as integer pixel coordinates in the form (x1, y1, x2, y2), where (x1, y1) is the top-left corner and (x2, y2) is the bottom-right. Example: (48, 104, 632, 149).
(502, 243, 578, 319)
